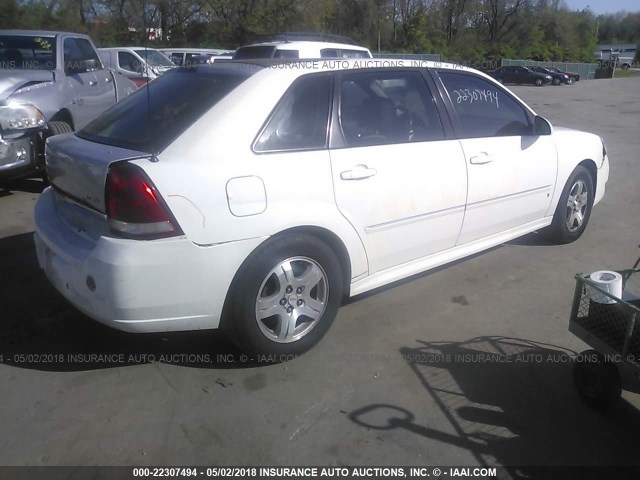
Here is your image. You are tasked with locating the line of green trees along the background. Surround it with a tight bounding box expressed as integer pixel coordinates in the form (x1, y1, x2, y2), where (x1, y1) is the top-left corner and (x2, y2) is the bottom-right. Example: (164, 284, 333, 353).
(0, 0, 640, 61)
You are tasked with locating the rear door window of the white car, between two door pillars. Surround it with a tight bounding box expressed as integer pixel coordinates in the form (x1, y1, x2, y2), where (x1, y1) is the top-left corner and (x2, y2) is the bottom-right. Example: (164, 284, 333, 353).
(340, 71, 444, 147)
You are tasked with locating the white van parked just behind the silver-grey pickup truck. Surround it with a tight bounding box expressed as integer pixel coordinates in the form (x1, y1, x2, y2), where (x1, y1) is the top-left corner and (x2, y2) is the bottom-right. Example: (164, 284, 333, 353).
(98, 47, 175, 87)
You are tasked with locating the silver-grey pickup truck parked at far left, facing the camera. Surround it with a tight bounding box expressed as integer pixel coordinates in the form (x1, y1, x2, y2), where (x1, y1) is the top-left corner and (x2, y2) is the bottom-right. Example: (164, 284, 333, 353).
(0, 30, 136, 180)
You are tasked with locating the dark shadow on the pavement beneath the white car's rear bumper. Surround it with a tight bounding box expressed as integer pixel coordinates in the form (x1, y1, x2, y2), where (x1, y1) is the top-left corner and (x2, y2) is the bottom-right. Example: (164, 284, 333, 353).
(0, 233, 264, 372)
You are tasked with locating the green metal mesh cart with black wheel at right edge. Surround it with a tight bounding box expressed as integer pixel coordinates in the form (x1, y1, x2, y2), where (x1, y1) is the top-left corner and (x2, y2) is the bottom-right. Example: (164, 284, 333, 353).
(569, 258, 640, 410)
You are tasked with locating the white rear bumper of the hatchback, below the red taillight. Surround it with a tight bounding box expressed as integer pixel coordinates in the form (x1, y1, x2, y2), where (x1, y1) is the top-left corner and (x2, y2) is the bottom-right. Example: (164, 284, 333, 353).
(34, 188, 262, 332)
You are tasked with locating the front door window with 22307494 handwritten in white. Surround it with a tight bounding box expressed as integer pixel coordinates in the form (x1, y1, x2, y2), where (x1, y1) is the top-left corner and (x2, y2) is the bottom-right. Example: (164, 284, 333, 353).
(439, 72, 532, 138)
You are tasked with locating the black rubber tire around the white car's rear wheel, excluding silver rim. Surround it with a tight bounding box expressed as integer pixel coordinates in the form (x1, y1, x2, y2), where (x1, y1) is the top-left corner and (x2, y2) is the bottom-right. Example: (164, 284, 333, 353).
(223, 234, 343, 361)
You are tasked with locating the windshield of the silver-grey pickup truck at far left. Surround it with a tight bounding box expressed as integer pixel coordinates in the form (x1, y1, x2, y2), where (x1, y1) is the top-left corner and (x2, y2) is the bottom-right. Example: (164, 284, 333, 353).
(0, 35, 56, 70)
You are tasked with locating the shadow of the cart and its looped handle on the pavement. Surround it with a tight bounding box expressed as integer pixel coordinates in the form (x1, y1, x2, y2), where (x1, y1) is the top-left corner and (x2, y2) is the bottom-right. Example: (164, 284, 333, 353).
(349, 336, 640, 478)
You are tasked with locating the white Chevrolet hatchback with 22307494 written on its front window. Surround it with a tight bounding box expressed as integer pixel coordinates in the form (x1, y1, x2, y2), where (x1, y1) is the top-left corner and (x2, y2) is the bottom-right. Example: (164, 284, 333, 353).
(35, 60, 609, 354)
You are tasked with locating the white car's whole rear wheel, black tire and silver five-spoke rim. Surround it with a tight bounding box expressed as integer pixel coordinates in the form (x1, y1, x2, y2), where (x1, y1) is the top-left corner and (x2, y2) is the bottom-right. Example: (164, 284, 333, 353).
(223, 234, 343, 361)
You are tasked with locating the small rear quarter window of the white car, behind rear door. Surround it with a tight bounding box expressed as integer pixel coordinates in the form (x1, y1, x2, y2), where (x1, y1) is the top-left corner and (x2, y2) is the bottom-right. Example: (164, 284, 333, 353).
(254, 74, 331, 152)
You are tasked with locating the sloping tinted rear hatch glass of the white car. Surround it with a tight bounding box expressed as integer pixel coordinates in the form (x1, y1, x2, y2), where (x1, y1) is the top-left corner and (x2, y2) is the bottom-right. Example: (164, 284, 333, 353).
(78, 68, 248, 153)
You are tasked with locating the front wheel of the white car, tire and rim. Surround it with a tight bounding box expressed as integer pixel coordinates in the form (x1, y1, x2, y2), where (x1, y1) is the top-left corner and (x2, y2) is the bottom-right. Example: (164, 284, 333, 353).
(547, 165, 594, 244)
